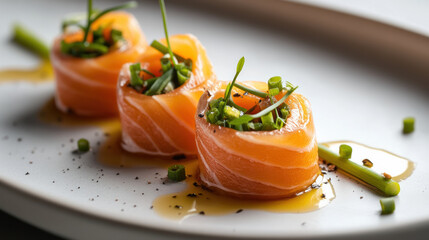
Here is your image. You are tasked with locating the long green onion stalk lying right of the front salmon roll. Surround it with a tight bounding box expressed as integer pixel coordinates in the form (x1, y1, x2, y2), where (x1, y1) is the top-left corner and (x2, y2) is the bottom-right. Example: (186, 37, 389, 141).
(319, 144, 400, 196)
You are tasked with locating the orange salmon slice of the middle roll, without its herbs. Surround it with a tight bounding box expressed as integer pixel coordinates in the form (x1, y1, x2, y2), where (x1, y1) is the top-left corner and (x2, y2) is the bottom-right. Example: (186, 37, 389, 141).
(117, 34, 216, 156)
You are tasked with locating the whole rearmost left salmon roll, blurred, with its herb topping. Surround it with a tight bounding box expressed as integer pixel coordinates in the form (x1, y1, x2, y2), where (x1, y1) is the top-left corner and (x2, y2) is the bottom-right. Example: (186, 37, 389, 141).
(51, 1, 148, 117)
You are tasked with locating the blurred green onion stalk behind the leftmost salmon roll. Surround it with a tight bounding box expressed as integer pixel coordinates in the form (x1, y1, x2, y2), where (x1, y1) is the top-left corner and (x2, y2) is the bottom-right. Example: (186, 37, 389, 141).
(12, 23, 49, 60)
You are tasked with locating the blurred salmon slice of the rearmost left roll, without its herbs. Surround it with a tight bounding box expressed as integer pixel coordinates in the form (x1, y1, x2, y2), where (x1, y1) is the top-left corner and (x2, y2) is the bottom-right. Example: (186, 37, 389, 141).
(51, 11, 148, 117)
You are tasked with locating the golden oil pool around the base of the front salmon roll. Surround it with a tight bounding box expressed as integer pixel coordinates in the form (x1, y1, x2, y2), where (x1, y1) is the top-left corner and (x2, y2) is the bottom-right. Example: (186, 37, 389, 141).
(153, 161, 335, 220)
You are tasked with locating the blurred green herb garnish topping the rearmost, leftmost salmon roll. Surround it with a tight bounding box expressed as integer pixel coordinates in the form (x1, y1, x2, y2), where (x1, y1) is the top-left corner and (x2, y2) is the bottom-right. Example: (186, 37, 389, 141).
(61, 0, 137, 58)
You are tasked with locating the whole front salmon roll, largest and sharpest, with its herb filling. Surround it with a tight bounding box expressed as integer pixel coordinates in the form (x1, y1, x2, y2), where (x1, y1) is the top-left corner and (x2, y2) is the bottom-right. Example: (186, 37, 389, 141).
(195, 58, 320, 200)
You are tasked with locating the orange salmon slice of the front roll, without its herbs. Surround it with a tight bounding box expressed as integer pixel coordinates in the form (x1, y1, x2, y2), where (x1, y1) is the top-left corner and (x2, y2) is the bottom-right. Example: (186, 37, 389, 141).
(195, 82, 320, 200)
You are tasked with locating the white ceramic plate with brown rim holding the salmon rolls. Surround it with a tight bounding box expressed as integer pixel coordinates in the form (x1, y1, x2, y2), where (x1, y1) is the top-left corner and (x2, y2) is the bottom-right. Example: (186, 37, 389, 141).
(0, 1, 429, 239)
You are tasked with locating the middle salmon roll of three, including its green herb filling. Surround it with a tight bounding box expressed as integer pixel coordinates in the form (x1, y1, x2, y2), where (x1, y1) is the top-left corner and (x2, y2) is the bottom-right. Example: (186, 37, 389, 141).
(117, 1, 216, 158)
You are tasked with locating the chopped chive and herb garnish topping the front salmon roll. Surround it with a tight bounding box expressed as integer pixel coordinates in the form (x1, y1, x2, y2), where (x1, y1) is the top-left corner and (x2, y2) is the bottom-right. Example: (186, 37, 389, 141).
(206, 57, 297, 131)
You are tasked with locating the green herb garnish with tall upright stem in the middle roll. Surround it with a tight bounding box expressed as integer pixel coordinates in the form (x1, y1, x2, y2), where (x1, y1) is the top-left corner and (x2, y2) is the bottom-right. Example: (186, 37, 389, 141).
(130, 0, 192, 96)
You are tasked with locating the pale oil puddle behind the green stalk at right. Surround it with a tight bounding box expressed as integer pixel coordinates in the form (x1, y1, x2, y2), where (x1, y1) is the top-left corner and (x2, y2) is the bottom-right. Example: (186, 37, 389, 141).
(322, 141, 414, 181)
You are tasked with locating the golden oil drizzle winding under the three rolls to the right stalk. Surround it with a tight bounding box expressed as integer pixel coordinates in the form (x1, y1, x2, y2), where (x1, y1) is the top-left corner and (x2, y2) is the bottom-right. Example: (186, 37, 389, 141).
(40, 99, 414, 220)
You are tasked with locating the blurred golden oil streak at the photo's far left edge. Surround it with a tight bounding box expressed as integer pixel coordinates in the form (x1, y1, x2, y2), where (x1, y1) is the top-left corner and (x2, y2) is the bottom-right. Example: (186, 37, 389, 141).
(0, 61, 54, 83)
